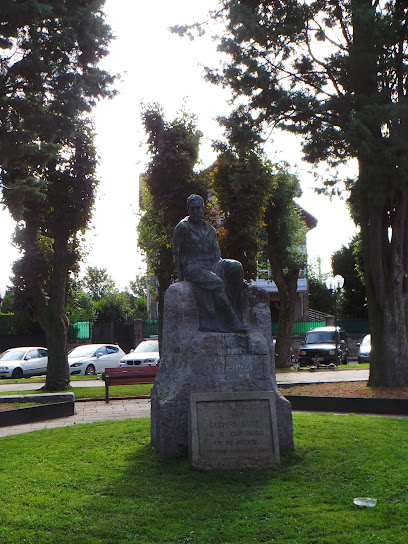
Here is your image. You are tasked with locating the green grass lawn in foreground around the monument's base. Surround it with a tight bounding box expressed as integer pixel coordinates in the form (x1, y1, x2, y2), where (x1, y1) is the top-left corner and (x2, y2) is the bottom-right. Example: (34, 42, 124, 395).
(0, 414, 408, 544)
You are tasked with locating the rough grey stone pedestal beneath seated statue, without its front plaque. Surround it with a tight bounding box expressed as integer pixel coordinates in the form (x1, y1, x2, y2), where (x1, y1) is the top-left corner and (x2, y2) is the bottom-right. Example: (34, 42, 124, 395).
(151, 282, 293, 457)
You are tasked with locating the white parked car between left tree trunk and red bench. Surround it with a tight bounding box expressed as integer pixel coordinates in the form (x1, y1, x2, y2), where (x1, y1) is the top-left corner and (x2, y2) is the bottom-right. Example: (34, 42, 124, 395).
(68, 344, 125, 376)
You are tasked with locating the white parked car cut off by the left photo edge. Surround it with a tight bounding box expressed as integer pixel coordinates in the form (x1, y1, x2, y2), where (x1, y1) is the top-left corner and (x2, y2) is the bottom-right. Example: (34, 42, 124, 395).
(0, 346, 48, 378)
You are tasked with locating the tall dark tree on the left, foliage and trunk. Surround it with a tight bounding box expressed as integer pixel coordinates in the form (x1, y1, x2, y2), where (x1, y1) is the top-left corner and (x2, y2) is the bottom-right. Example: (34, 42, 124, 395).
(0, 0, 113, 391)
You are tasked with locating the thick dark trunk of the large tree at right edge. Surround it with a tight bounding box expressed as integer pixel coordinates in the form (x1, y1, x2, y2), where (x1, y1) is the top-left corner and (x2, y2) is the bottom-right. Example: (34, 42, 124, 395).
(350, 0, 408, 387)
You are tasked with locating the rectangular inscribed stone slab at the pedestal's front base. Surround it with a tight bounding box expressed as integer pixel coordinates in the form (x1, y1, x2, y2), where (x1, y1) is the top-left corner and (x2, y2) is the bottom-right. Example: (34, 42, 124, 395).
(191, 392, 279, 468)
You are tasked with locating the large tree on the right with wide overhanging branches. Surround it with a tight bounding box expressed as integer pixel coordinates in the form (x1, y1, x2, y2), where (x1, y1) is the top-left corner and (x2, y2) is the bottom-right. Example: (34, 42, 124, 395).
(189, 0, 408, 386)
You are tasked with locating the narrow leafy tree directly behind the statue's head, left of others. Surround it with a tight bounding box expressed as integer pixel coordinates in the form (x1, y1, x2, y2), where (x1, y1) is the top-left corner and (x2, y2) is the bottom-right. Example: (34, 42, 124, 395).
(138, 105, 207, 338)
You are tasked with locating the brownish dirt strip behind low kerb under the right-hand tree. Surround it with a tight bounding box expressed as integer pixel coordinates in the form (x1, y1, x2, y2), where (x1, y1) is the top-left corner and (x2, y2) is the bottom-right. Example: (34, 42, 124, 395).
(281, 382, 408, 399)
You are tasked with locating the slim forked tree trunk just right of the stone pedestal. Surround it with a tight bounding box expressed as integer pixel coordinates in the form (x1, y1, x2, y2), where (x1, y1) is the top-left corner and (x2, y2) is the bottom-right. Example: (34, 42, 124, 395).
(269, 257, 299, 368)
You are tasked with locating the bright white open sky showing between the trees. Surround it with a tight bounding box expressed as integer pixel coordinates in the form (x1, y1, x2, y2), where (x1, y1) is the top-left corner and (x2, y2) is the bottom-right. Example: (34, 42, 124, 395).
(0, 0, 355, 298)
